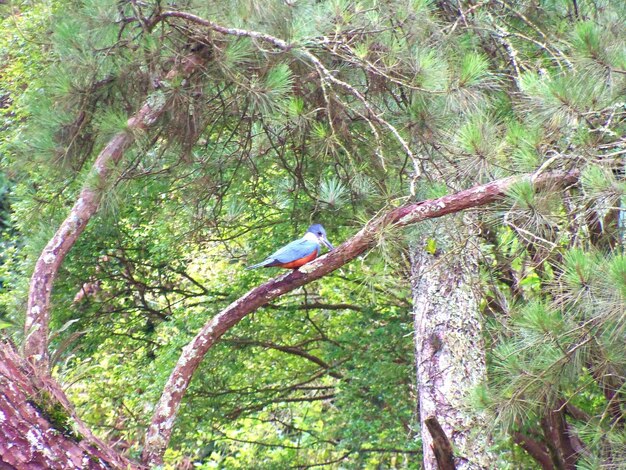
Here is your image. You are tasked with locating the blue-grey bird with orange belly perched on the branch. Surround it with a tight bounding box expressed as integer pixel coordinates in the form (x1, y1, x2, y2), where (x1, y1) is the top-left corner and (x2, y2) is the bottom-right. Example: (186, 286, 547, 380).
(246, 224, 335, 269)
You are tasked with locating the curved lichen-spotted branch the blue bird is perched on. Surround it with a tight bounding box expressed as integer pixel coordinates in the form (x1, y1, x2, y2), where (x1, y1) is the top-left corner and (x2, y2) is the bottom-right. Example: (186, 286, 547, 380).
(142, 170, 579, 465)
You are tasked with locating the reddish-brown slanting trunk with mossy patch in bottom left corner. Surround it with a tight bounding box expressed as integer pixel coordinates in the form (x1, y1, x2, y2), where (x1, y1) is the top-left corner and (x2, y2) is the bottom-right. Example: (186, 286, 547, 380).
(0, 342, 138, 470)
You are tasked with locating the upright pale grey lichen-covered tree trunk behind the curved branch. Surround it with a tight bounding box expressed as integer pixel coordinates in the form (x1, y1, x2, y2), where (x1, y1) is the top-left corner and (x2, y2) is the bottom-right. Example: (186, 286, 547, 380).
(411, 221, 495, 470)
